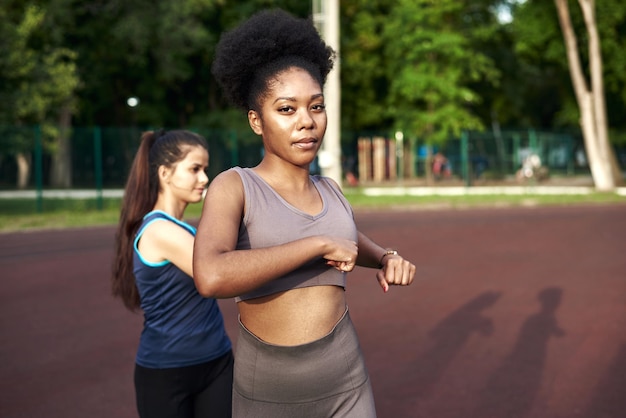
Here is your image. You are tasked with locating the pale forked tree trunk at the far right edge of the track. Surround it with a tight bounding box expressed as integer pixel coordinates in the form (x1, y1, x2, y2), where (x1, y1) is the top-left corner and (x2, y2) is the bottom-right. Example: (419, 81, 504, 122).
(554, 0, 619, 191)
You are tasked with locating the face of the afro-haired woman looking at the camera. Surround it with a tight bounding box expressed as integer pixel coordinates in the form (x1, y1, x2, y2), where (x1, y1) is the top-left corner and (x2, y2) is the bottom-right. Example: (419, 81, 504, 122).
(248, 67, 326, 167)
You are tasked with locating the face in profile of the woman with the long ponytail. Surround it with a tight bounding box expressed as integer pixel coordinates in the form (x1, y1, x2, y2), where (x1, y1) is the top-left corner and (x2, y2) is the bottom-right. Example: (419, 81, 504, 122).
(161, 146, 209, 203)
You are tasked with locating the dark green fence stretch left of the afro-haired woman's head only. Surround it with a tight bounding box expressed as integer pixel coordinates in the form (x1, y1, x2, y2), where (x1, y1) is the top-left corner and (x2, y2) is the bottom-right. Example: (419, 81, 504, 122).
(0, 127, 262, 190)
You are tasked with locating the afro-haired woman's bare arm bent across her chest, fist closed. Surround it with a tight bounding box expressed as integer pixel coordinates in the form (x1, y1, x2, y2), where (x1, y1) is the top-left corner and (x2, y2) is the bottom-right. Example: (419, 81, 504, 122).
(193, 171, 357, 298)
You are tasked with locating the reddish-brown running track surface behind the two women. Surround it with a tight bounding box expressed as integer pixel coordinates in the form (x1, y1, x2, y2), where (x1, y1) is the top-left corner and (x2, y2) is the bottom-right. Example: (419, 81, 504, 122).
(0, 206, 626, 418)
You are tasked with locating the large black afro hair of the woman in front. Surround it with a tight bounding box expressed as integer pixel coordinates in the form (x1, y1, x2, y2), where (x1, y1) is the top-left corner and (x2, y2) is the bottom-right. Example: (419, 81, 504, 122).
(212, 9, 335, 111)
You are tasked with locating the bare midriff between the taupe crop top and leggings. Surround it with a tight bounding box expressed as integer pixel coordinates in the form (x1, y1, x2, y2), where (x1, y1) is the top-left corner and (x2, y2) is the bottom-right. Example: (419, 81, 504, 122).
(238, 286, 346, 346)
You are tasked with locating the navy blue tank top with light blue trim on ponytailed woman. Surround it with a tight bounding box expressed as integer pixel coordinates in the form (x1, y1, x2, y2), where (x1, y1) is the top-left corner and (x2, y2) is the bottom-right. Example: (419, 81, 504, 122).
(133, 211, 231, 368)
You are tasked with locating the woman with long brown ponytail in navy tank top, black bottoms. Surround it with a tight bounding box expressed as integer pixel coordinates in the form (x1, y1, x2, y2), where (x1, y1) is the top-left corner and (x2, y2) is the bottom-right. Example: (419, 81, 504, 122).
(112, 130, 233, 418)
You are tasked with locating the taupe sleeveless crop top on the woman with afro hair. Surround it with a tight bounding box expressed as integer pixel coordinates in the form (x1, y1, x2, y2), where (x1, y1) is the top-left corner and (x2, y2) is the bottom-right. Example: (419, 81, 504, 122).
(231, 167, 358, 302)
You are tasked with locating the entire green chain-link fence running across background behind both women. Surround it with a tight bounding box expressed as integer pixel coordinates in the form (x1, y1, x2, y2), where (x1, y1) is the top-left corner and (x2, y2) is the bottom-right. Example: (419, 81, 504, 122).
(0, 126, 626, 202)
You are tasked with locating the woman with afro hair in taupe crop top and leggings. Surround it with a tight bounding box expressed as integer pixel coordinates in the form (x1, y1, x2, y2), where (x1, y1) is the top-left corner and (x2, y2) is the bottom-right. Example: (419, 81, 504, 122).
(193, 10, 415, 418)
